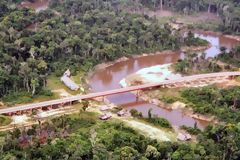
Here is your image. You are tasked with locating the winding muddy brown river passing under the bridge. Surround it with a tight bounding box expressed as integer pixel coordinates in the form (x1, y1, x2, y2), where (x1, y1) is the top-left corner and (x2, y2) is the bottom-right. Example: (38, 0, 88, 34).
(89, 32, 239, 129)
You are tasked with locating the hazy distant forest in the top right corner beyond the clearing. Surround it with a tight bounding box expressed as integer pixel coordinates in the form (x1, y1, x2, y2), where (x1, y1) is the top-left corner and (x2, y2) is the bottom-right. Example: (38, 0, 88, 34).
(135, 0, 240, 33)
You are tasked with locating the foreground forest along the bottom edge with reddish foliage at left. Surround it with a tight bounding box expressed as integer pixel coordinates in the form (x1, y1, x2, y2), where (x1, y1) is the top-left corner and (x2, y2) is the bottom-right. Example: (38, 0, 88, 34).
(0, 112, 240, 160)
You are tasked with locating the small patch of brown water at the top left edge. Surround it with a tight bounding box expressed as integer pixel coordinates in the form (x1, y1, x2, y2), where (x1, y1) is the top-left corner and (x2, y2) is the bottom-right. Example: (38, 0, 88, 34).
(21, 0, 49, 12)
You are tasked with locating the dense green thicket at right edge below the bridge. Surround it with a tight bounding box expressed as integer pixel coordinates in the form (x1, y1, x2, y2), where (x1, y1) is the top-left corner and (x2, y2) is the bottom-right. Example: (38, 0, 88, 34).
(181, 86, 240, 123)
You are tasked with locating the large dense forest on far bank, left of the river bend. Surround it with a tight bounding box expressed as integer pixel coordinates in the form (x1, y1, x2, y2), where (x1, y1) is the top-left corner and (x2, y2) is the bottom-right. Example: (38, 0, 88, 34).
(0, 0, 184, 97)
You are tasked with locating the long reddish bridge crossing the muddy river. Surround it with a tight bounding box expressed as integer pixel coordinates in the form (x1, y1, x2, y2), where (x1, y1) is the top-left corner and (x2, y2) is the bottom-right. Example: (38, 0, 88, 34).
(0, 72, 240, 115)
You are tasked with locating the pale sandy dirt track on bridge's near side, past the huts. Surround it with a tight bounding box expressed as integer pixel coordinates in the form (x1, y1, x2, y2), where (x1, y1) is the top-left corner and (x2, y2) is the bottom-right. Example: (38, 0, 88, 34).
(0, 100, 178, 141)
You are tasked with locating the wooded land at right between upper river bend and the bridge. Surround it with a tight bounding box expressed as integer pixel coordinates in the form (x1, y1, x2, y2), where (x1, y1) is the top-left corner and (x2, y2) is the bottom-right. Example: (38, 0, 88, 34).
(173, 43, 240, 75)
